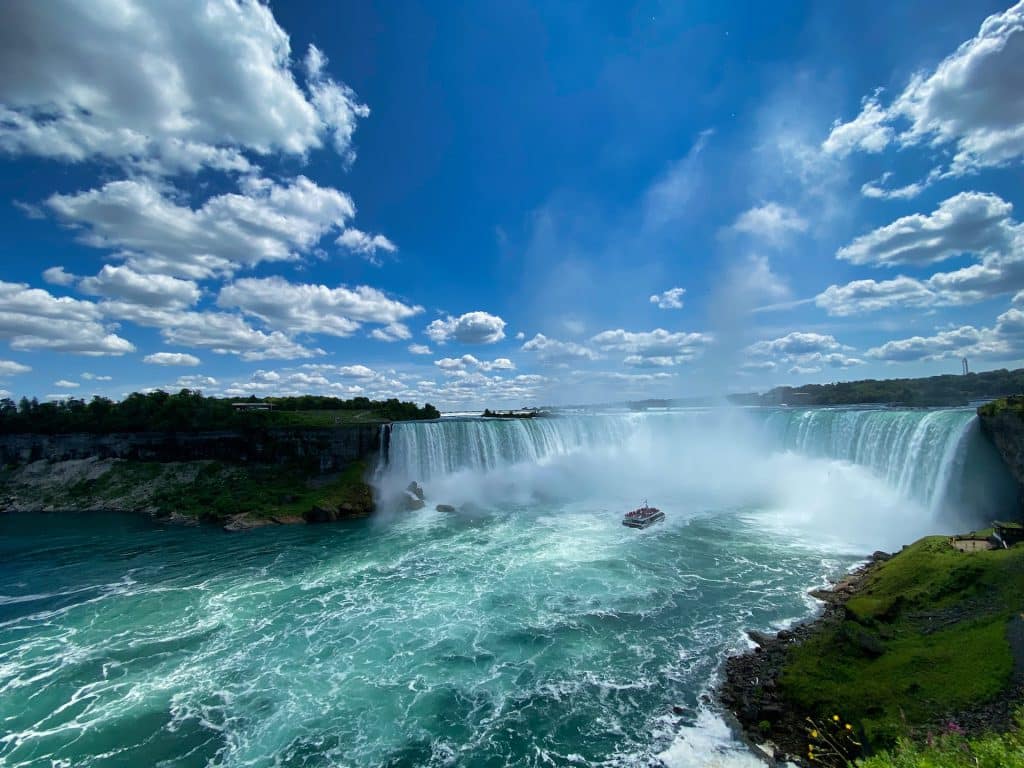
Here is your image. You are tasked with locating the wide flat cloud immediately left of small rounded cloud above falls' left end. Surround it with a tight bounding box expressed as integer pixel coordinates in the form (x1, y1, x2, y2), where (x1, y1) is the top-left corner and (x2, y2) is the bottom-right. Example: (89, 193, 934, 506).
(217, 276, 423, 341)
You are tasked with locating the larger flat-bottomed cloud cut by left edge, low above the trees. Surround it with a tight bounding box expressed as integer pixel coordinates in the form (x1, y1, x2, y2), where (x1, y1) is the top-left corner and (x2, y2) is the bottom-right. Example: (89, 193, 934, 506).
(0, 281, 135, 355)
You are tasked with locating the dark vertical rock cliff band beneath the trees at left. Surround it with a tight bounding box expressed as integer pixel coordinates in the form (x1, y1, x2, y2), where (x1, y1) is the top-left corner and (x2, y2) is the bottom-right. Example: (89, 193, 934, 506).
(0, 424, 381, 472)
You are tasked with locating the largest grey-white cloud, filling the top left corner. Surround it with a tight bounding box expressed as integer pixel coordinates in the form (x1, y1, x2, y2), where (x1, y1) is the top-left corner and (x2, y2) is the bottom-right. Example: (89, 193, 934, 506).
(0, 0, 369, 173)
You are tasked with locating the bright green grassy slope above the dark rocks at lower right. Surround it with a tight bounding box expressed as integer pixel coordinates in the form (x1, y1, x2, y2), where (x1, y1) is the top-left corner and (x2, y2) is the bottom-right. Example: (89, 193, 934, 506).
(780, 537, 1024, 745)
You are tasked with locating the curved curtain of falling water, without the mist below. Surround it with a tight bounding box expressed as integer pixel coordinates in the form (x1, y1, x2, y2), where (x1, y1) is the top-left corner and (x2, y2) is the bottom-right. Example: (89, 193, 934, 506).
(378, 408, 1015, 518)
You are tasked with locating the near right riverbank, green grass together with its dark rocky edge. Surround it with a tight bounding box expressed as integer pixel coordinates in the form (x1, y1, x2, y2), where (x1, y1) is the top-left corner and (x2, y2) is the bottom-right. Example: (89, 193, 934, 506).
(719, 537, 1024, 765)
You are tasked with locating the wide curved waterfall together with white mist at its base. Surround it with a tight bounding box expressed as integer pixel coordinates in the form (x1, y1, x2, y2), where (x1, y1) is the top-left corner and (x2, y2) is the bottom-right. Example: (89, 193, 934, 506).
(378, 408, 1015, 547)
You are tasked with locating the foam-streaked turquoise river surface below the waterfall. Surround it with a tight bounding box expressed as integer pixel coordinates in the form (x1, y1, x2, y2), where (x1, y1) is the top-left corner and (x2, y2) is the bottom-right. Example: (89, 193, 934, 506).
(0, 508, 853, 767)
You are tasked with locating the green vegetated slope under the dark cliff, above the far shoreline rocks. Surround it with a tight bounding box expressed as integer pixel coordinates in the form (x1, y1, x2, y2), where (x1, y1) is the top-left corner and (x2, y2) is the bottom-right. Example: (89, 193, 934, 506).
(25, 461, 373, 518)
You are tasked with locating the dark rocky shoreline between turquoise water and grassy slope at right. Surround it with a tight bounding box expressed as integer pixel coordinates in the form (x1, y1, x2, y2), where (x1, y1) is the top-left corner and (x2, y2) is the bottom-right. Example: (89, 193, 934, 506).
(716, 552, 891, 765)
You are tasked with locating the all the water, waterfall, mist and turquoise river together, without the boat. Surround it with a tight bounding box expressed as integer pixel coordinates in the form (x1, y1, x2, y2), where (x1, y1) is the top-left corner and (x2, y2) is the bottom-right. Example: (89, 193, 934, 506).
(0, 409, 1009, 767)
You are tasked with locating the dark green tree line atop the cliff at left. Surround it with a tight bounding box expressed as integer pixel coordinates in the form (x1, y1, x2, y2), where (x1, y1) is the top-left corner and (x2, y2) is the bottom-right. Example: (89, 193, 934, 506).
(0, 389, 440, 434)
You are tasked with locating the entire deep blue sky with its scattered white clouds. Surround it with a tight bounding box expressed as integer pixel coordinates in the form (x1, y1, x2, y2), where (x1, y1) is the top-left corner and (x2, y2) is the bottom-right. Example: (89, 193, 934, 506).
(0, 0, 1024, 410)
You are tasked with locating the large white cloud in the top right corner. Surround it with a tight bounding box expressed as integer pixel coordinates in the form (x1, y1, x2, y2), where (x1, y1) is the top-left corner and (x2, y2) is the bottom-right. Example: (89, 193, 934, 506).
(823, 2, 1024, 175)
